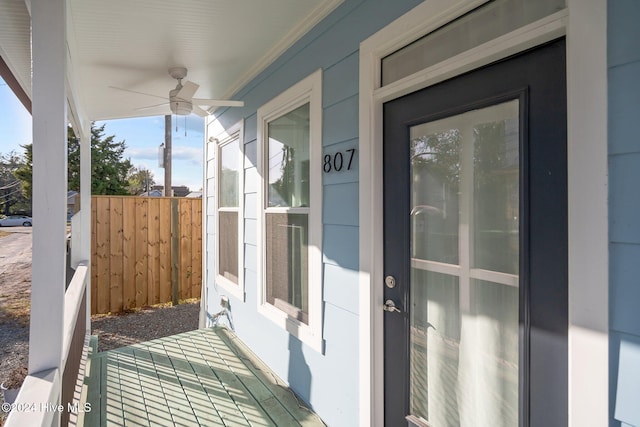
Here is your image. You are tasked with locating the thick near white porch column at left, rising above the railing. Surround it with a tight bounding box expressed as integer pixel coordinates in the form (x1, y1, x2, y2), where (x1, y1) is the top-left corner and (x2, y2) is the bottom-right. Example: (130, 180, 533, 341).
(29, 0, 67, 374)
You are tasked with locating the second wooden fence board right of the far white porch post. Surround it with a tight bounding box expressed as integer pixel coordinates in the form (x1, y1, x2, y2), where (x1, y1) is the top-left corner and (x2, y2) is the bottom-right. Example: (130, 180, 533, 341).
(109, 197, 123, 313)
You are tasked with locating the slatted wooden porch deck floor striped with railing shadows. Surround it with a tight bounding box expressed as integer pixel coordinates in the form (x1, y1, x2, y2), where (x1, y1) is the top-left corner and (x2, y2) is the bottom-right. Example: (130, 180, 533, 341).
(78, 328, 324, 427)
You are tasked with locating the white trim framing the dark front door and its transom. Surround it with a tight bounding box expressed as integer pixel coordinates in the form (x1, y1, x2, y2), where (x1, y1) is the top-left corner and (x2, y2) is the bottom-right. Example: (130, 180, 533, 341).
(359, 0, 609, 426)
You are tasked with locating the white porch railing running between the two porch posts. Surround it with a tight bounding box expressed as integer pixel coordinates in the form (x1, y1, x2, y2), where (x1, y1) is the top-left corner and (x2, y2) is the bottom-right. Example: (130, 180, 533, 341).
(5, 262, 89, 427)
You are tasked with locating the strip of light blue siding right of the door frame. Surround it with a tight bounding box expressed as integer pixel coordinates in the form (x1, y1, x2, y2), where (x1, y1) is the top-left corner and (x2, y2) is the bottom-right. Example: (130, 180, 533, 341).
(607, 0, 640, 427)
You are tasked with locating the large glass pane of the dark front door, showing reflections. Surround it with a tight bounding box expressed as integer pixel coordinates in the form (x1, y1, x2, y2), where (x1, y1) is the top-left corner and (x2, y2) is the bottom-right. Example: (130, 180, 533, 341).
(409, 100, 520, 427)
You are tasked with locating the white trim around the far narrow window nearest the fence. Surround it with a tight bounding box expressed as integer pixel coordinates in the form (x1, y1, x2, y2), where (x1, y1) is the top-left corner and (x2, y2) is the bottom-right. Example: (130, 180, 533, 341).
(210, 121, 245, 302)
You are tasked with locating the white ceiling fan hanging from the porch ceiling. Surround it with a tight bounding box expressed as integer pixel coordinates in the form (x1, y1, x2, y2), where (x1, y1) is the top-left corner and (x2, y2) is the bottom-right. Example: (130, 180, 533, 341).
(109, 67, 244, 117)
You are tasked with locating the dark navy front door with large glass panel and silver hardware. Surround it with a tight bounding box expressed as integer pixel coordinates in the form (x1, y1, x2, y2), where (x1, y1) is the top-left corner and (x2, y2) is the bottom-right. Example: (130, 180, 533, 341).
(380, 40, 568, 427)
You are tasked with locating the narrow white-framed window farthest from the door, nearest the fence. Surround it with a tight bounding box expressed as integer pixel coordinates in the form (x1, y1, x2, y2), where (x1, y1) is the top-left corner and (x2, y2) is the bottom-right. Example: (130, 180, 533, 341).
(212, 125, 244, 300)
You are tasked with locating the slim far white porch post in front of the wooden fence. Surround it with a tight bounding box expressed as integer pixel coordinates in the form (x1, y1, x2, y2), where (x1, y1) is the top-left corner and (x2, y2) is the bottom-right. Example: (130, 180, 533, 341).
(80, 122, 91, 333)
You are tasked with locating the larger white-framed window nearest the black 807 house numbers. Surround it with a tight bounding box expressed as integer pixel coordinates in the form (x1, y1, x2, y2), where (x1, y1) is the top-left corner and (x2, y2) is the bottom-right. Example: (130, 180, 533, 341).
(258, 71, 322, 351)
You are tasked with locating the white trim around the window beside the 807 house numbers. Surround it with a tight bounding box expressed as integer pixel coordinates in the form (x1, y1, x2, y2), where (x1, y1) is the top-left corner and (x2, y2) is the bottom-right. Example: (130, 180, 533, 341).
(257, 70, 324, 352)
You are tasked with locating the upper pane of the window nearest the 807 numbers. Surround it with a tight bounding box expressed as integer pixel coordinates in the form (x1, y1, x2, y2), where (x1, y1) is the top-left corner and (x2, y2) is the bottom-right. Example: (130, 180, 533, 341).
(268, 103, 309, 207)
